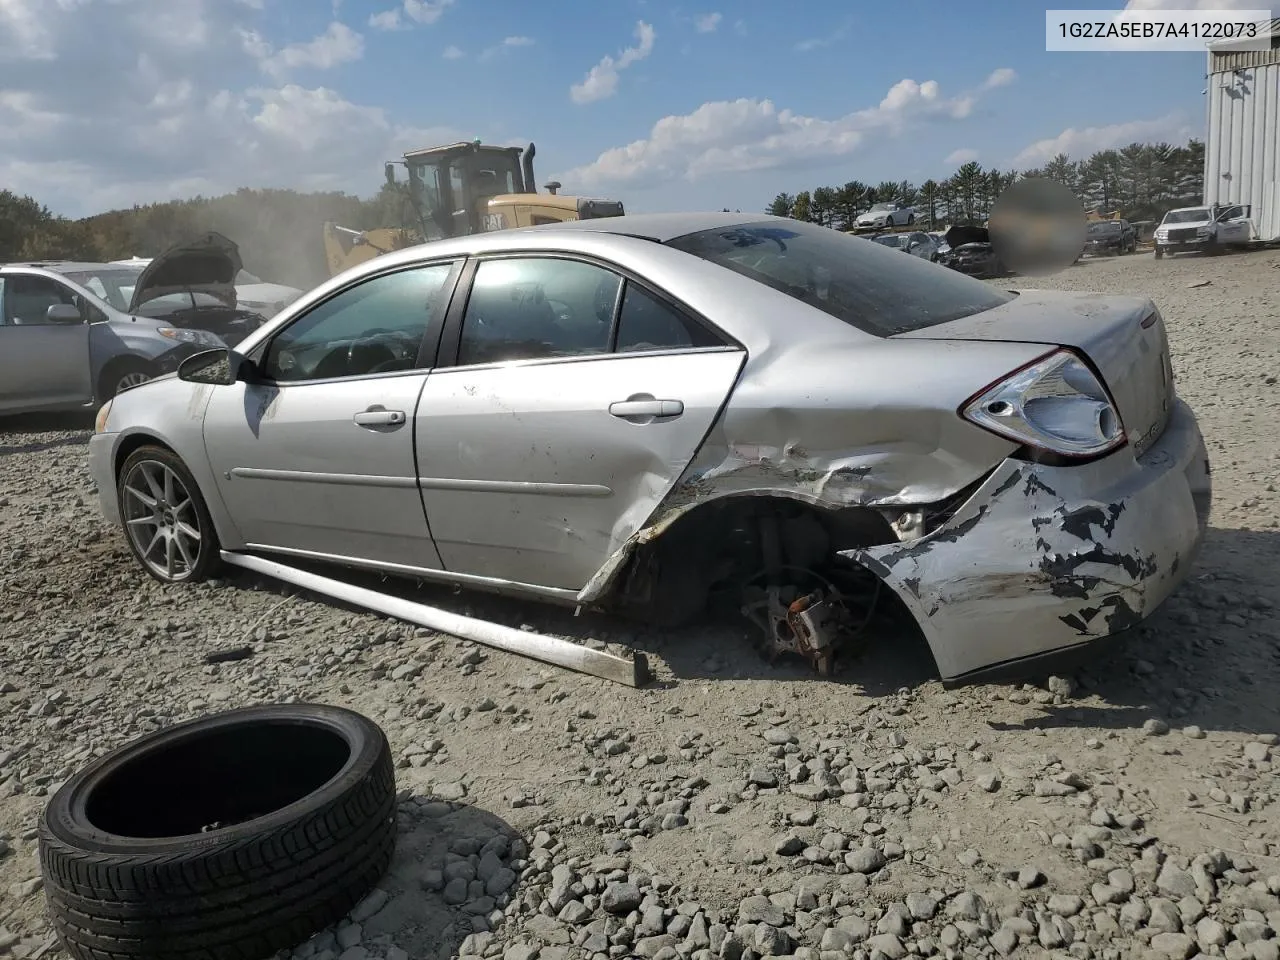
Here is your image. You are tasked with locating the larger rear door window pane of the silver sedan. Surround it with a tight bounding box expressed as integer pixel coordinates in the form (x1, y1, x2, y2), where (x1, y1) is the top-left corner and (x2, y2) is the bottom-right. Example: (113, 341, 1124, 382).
(458, 257, 622, 365)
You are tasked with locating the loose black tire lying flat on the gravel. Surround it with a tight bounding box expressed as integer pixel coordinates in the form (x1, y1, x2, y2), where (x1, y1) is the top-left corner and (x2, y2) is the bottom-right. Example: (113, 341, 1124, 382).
(40, 704, 396, 960)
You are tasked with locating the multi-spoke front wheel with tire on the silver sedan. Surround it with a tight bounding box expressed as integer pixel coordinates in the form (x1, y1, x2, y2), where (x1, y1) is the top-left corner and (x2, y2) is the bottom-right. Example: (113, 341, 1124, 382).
(115, 445, 221, 584)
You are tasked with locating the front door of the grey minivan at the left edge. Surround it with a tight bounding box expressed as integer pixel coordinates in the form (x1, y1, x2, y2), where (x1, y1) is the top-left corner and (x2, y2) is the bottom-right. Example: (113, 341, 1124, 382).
(0, 273, 93, 413)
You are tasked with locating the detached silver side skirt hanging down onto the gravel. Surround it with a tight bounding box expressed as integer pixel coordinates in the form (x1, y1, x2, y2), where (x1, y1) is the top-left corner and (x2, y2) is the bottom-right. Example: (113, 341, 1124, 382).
(221, 550, 650, 687)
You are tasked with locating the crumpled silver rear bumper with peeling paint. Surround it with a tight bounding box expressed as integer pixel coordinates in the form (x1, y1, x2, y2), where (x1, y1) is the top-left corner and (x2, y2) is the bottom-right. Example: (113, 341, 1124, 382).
(841, 401, 1212, 681)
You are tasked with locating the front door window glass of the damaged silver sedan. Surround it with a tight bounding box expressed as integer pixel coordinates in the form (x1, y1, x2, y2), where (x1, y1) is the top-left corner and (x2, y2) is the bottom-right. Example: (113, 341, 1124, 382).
(262, 264, 453, 381)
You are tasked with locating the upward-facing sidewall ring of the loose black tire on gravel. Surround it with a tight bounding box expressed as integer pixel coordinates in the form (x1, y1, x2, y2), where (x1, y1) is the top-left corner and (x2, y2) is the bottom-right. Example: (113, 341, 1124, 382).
(40, 704, 389, 856)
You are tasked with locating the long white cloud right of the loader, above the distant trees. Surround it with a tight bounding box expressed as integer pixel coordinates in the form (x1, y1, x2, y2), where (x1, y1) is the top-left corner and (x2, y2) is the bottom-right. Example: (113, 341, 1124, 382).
(557, 79, 998, 189)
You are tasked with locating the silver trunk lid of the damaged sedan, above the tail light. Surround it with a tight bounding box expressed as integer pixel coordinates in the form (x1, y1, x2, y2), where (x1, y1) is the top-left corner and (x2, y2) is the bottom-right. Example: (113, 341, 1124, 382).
(896, 291, 1175, 456)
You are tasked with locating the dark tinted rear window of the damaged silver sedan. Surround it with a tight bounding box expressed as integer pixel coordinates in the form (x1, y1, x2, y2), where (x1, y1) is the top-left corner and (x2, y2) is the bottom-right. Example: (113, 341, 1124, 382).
(667, 220, 1014, 337)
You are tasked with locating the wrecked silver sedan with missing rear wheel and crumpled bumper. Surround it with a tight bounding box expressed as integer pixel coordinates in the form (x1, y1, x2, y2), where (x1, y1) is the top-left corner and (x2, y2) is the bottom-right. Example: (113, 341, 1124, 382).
(90, 212, 1211, 682)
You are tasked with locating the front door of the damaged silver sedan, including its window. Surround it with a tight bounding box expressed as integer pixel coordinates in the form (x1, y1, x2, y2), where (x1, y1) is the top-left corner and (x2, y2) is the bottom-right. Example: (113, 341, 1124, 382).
(205, 264, 456, 568)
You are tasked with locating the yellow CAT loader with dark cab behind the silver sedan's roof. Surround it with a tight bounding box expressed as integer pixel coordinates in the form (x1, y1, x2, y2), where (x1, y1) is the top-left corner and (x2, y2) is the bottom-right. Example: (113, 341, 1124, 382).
(324, 140, 625, 276)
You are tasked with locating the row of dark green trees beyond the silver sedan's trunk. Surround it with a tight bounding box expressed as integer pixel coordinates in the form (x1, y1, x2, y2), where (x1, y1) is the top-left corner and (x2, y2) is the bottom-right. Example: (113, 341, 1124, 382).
(765, 140, 1204, 230)
